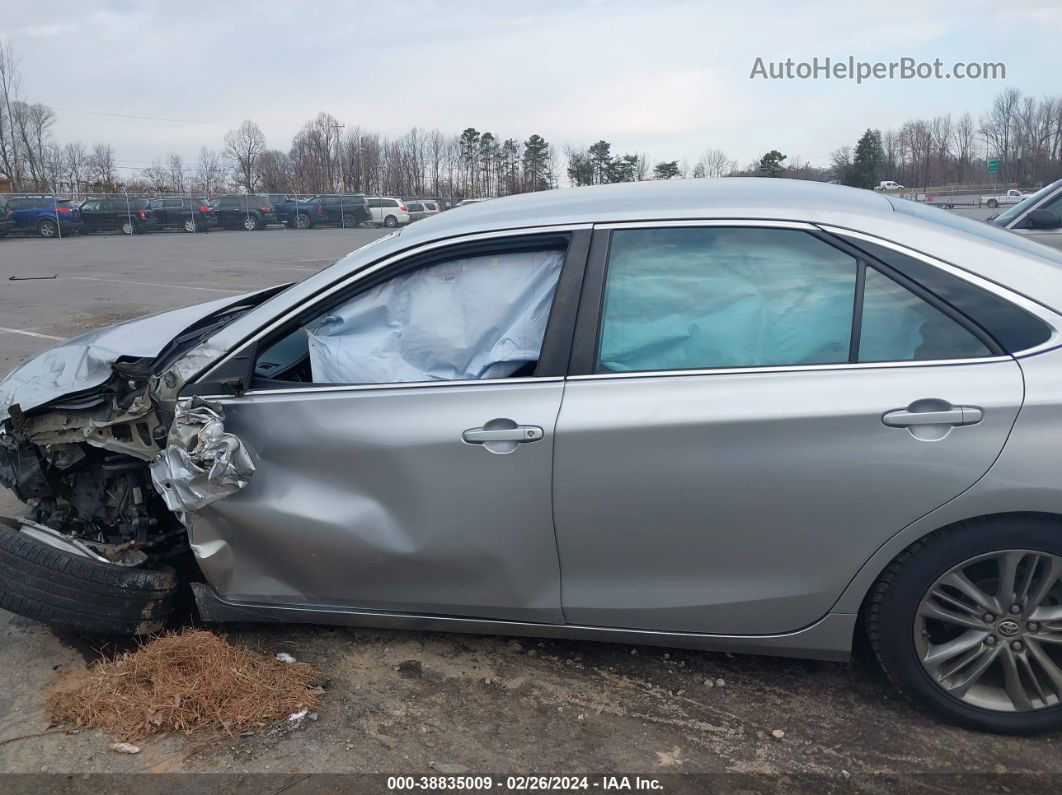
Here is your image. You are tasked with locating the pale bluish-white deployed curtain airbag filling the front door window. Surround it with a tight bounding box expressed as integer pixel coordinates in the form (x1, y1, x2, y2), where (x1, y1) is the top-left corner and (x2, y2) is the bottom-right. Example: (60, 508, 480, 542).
(306, 250, 564, 383)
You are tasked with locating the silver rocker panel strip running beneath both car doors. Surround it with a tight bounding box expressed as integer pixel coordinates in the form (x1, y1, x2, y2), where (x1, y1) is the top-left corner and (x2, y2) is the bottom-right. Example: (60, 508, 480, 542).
(191, 583, 858, 662)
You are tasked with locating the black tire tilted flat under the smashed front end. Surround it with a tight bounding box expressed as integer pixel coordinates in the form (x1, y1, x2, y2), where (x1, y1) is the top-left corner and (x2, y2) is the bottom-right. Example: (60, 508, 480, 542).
(0, 528, 177, 635)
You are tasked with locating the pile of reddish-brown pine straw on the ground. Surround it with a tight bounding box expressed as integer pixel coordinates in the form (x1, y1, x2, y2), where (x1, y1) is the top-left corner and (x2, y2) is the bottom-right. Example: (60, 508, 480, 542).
(48, 629, 321, 740)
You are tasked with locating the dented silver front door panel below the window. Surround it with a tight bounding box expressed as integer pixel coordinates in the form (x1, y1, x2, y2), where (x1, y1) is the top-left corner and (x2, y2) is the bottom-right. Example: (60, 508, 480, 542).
(184, 379, 563, 622)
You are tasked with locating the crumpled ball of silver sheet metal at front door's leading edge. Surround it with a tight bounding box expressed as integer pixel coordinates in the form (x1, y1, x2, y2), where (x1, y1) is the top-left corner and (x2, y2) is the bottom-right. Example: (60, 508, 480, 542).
(151, 398, 255, 517)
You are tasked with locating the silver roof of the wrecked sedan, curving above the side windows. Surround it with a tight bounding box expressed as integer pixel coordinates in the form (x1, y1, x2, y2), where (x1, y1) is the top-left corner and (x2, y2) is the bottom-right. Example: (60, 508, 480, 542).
(202, 177, 1062, 356)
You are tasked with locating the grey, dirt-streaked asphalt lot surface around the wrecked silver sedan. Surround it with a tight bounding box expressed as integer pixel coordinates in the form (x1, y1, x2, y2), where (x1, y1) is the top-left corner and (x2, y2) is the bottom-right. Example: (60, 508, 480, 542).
(0, 229, 1062, 791)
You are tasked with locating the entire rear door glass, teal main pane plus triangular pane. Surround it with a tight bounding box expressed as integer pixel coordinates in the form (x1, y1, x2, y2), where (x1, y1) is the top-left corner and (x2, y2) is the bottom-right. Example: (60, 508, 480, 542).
(596, 222, 995, 373)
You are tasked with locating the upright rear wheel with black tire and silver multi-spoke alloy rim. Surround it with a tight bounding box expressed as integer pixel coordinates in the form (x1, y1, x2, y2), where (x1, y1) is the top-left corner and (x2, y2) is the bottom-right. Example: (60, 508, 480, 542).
(867, 514, 1062, 734)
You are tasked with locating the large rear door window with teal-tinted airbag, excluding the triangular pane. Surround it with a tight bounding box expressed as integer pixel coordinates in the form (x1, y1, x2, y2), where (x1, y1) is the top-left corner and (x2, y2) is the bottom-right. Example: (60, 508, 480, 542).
(598, 227, 858, 371)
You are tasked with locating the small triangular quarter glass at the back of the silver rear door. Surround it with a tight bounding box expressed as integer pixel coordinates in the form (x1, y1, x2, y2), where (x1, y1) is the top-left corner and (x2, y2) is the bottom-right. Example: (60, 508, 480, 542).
(858, 267, 992, 362)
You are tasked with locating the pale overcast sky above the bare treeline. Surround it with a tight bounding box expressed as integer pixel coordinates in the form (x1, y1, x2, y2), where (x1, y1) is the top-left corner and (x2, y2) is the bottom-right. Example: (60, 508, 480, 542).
(0, 0, 1062, 174)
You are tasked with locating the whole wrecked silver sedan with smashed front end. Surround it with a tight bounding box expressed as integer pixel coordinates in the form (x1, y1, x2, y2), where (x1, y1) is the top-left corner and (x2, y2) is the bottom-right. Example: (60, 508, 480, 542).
(0, 179, 1062, 732)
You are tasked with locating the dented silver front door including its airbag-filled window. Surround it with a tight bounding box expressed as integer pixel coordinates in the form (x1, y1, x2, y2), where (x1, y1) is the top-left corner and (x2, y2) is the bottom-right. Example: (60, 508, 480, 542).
(182, 235, 585, 622)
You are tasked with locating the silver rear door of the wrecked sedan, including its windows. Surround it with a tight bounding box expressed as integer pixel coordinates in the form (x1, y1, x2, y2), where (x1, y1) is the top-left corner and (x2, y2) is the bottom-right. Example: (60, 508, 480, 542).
(553, 222, 1023, 635)
